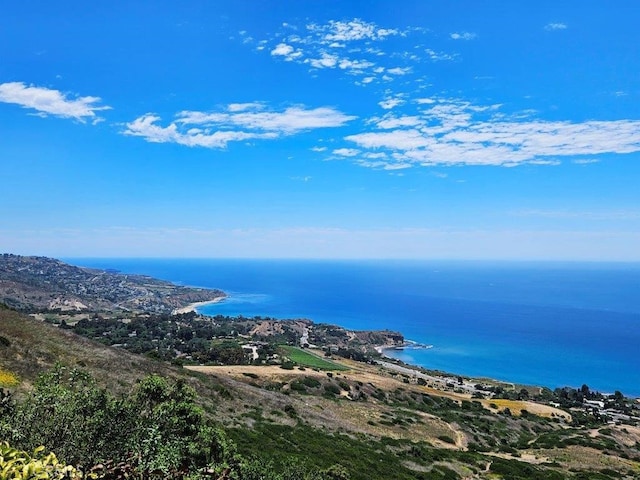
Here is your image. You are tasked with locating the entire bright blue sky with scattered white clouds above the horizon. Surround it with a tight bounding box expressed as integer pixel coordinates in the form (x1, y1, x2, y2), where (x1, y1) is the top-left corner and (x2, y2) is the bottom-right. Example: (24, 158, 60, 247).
(0, 0, 640, 261)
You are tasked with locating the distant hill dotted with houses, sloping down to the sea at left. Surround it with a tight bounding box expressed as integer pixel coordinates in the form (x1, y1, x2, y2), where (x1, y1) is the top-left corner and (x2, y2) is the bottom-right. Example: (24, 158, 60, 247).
(0, 253, 224, 313)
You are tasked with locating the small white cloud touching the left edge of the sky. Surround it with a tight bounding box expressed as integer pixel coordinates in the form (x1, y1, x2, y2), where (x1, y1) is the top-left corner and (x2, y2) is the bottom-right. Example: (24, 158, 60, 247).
(0, 82, 111, 123)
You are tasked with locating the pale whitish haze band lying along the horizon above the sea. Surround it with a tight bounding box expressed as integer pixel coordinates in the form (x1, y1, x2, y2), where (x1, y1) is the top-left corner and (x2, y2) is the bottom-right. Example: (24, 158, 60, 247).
(6, 225, 640, 262)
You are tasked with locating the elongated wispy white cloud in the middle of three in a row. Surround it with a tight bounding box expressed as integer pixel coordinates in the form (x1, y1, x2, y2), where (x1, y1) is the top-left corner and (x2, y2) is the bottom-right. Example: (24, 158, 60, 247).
(123, 102, 356, 148)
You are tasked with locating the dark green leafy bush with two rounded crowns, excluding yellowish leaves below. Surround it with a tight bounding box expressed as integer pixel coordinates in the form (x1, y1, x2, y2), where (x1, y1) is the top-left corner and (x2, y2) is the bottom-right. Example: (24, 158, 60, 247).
(2, 367, 233, 475)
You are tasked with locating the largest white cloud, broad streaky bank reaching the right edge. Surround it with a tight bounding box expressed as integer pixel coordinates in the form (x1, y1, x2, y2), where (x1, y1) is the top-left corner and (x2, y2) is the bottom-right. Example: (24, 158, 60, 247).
(345, 98, 640, 166)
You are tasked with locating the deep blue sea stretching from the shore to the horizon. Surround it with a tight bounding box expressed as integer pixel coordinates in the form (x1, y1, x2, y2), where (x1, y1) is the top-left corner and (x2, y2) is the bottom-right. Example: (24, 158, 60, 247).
(66, 258, 640, 396)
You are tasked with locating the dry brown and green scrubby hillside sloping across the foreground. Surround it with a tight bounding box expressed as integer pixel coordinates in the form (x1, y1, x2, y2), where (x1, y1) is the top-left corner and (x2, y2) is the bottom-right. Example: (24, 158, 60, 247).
(0, 308, 640, 479)
